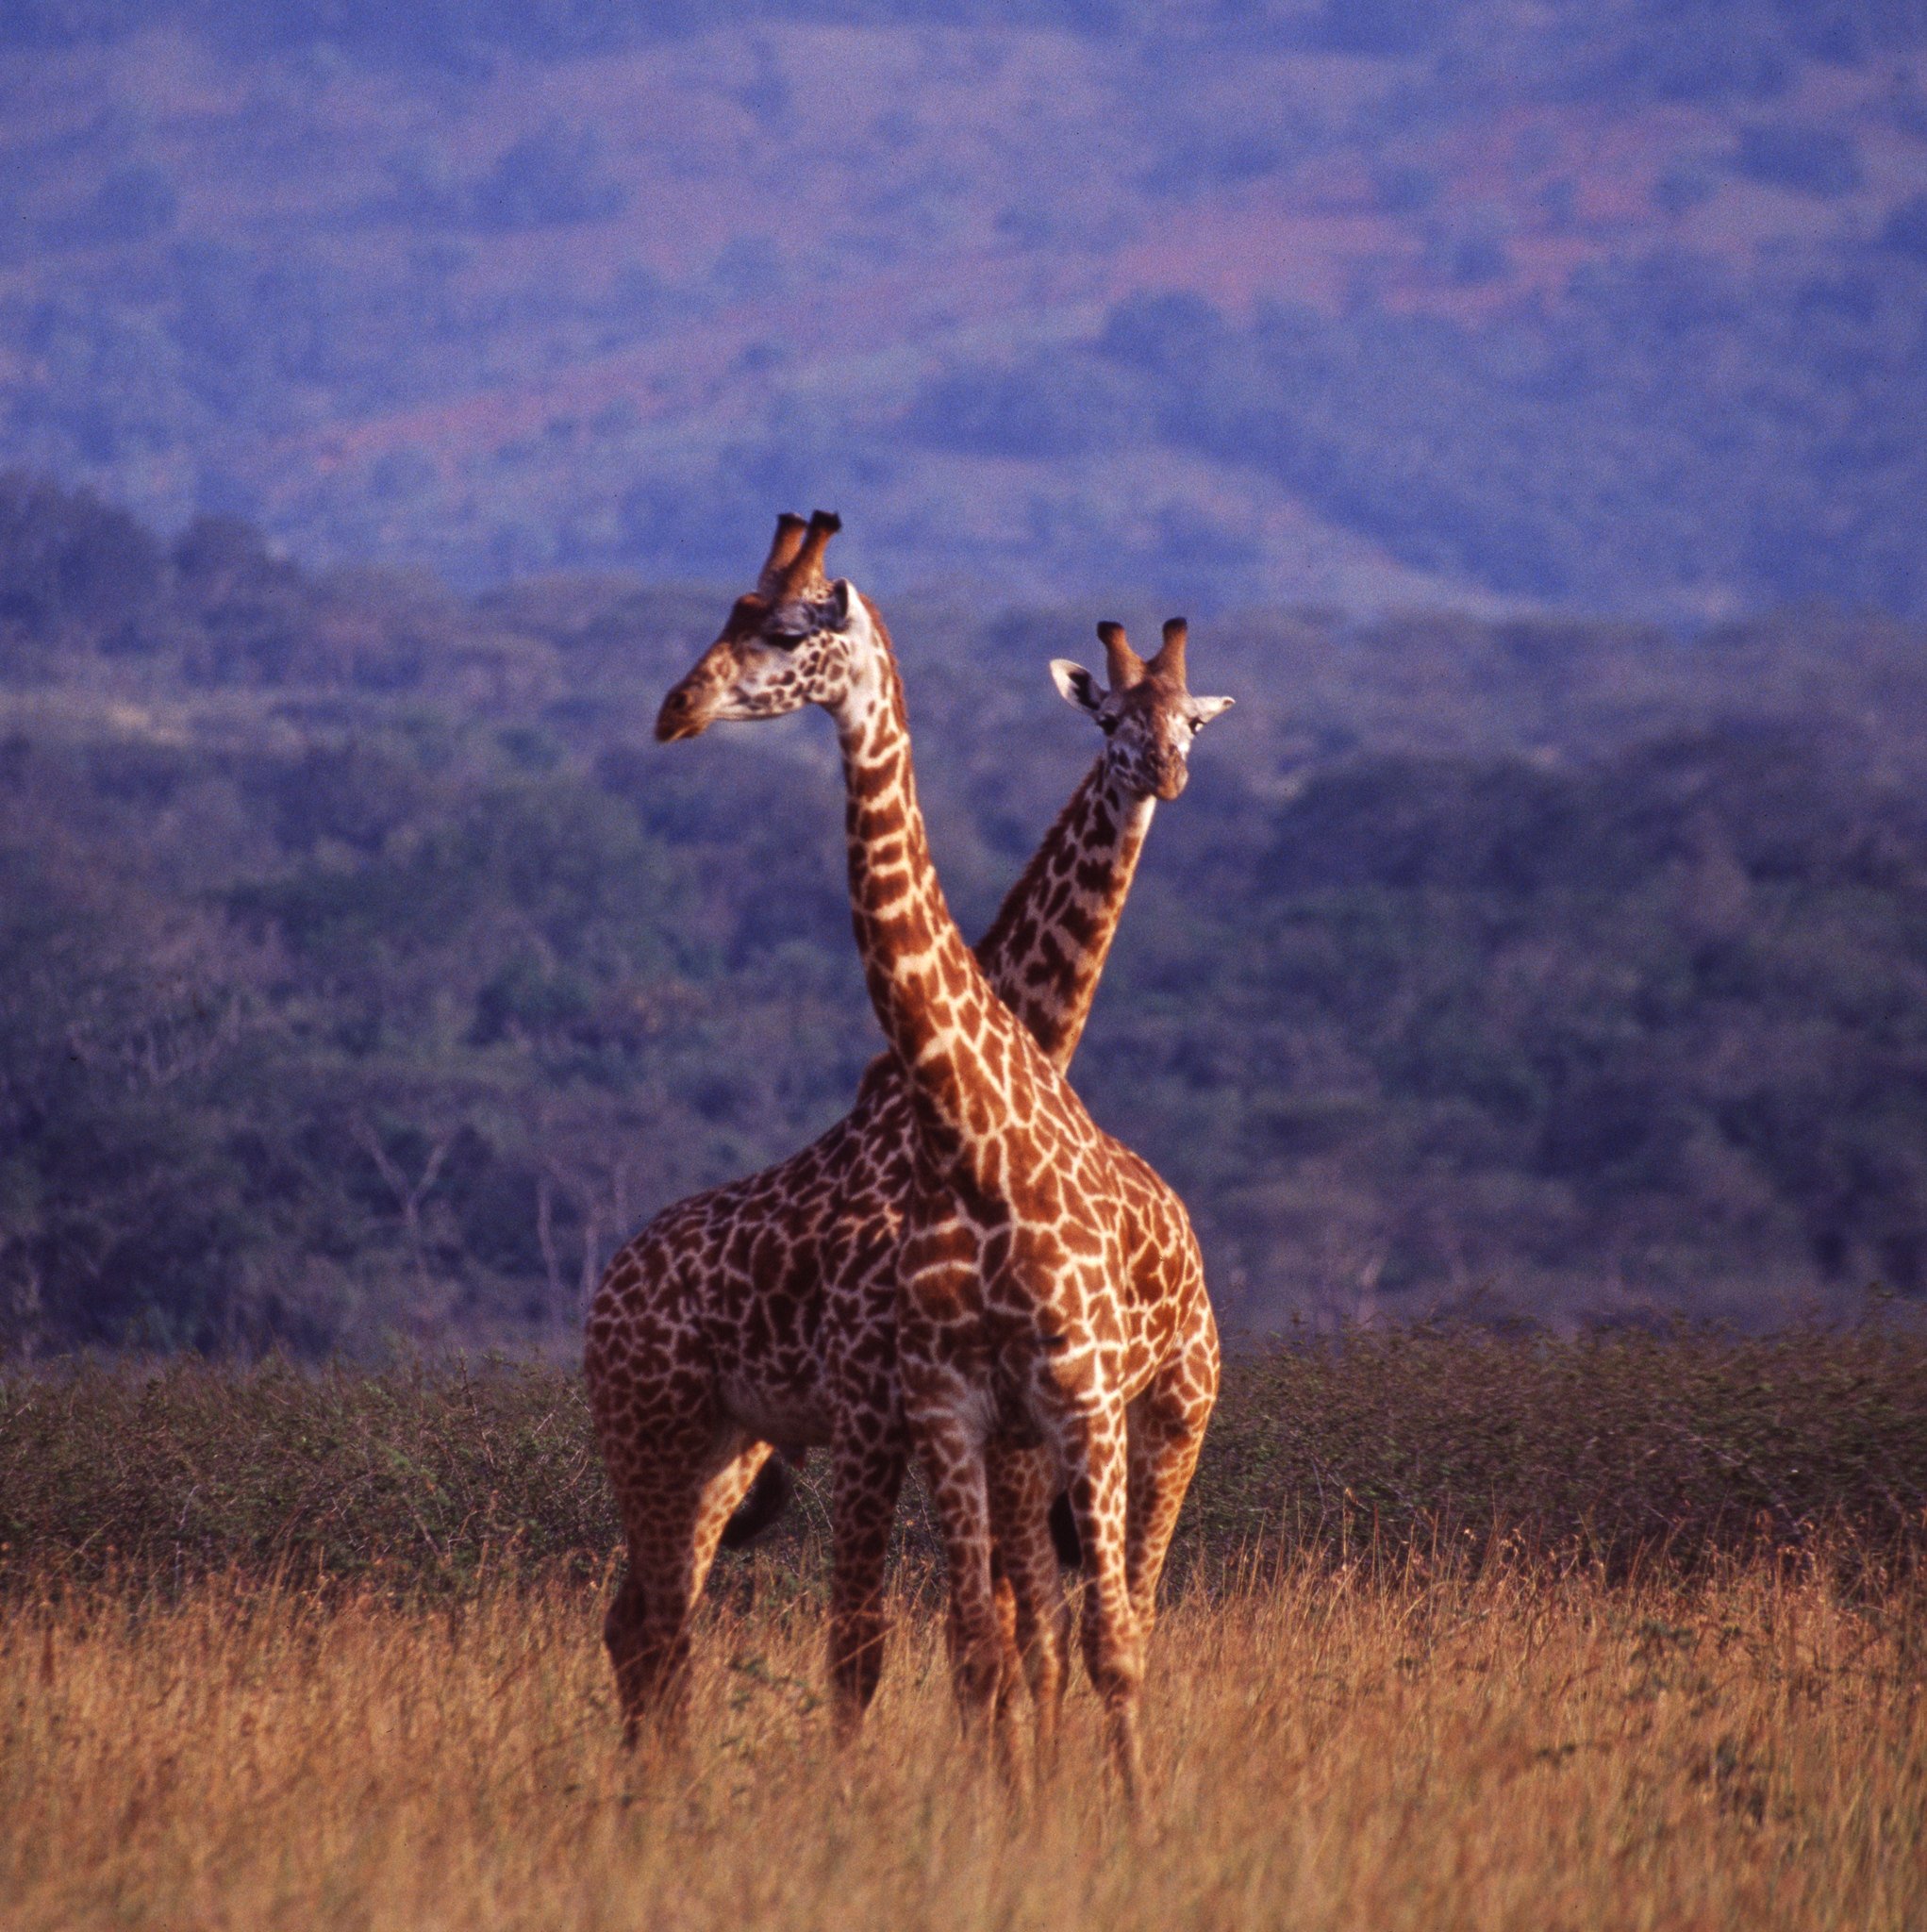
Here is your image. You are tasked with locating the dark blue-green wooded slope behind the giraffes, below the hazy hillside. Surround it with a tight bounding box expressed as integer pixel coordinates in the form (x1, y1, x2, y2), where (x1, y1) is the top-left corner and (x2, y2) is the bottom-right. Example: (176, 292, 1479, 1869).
(0, 475, 1927, 1351)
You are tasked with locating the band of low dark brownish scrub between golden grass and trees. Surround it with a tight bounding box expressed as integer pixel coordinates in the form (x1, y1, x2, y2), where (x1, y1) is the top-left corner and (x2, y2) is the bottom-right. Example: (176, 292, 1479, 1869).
(0, 1320, 1927, 1604)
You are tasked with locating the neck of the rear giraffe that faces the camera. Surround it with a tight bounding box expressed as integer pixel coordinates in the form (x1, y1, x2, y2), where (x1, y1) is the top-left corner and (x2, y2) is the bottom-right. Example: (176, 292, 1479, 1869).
(977, 758, 1156, 1071)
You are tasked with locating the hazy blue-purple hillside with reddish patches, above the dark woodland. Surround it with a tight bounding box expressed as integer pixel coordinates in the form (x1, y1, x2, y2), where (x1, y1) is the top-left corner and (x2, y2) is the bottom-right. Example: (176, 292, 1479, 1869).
(0, 0, 1927, 618)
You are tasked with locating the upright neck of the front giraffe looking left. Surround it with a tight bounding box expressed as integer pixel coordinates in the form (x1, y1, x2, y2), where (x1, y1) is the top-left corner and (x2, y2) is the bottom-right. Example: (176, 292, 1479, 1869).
(832, 601, 1025, 1173)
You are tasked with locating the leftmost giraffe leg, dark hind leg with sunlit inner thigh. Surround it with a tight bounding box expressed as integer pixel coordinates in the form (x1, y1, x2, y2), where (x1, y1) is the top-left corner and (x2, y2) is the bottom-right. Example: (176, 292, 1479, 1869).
(603, 1434, 771, 1746)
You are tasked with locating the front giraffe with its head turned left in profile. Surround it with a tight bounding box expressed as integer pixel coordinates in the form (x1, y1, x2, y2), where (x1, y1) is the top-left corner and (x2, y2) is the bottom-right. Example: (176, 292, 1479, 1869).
(656, 512, 1219, 1797)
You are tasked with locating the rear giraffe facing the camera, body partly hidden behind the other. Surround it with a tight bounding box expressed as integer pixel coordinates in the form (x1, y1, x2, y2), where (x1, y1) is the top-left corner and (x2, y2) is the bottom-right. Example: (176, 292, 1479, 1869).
(585, 516, 1230, 1760)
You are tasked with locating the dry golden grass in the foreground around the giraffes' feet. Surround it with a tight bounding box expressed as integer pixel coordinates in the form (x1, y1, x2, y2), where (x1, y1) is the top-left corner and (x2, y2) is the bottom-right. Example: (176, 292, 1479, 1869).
(0, 1567, 1927, 1932)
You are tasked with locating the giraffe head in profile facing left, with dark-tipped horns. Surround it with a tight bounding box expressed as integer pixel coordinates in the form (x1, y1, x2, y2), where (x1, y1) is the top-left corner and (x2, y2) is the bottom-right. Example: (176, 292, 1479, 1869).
(656, 510, 871, 743)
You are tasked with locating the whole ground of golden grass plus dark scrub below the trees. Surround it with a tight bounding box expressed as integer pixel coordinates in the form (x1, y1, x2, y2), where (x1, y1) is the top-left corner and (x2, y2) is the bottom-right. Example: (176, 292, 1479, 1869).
(0, 1327, 1927, 1932)
